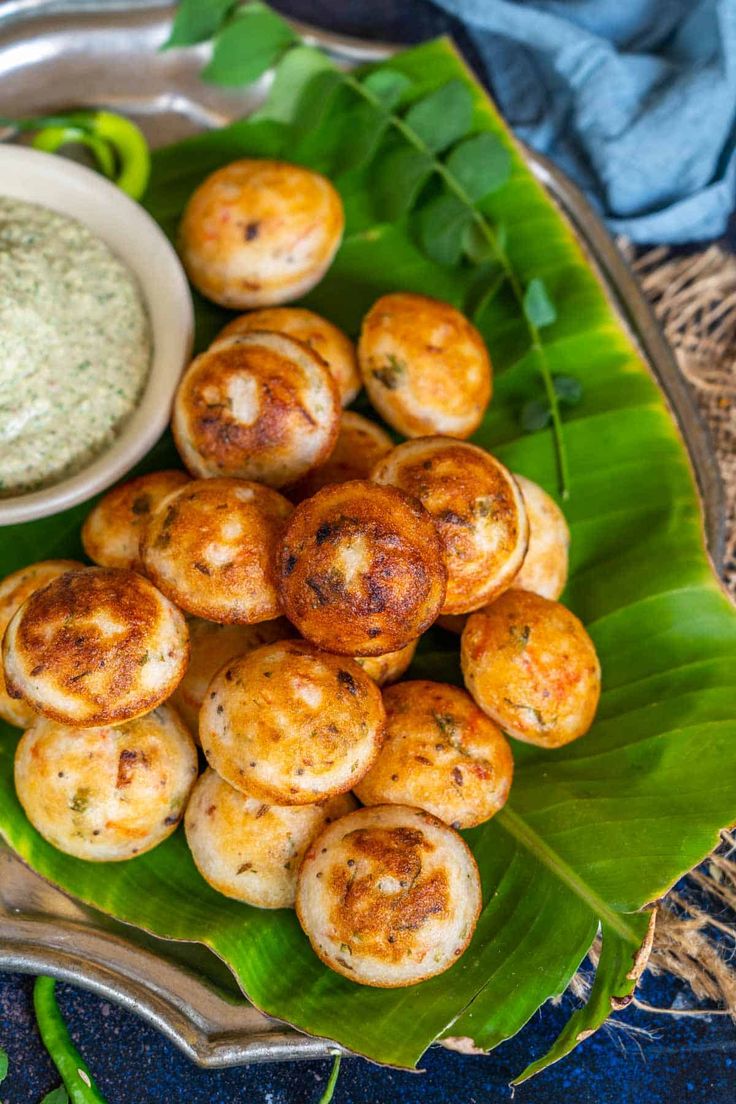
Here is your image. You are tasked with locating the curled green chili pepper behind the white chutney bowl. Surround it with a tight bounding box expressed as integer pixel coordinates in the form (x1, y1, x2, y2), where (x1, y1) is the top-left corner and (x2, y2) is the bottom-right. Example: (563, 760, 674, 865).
(0, 112, 151, 200)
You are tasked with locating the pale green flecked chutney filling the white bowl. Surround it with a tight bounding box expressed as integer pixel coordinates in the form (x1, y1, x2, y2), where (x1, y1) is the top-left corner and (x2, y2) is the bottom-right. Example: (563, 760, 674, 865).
(0, 195, 151, 498)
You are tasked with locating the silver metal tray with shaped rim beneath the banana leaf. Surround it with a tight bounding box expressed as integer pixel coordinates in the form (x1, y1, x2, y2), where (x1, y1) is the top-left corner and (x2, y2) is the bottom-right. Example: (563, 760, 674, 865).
(0, 0, 724, 1066)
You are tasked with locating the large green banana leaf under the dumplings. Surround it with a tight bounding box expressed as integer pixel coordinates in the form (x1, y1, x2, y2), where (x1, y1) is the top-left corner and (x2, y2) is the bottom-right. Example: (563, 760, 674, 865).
(0, 34, 736, 1078)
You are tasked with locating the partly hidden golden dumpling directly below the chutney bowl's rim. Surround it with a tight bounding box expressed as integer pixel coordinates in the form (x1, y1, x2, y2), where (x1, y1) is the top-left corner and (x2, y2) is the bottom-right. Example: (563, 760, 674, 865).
(82, 471, 189, 571)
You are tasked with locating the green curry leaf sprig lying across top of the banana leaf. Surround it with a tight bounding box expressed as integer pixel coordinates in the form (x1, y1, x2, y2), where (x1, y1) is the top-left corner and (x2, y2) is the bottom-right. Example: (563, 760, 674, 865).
(167, 0, 569, 498)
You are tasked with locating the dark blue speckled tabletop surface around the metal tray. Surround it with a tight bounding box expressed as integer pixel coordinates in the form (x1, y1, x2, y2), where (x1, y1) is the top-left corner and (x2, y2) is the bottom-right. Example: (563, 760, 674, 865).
(0, 0, 736, 1104)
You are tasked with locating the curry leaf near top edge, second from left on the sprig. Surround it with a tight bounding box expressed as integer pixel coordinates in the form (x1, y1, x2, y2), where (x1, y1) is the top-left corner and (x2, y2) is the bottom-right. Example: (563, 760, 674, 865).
(202, 2, 298, 85)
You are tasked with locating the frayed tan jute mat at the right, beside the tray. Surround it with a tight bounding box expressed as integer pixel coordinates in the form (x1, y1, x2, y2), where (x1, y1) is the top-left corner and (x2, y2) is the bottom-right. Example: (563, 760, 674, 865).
(600, 242, 736, 1022)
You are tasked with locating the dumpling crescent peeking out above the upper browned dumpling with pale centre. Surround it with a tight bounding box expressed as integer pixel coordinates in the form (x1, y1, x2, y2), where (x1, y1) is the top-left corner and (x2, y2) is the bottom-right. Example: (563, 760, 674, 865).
(213, 307, 361, 406)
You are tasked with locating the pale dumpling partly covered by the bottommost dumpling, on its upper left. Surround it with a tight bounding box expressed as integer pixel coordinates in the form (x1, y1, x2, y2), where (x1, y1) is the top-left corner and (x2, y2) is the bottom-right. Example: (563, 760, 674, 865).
(184, 769, 358, 909)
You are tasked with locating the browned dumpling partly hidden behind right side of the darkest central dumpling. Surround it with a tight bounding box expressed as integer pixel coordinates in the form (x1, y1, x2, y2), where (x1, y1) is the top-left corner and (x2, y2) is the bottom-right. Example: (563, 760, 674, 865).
(372, 437, 529, 614)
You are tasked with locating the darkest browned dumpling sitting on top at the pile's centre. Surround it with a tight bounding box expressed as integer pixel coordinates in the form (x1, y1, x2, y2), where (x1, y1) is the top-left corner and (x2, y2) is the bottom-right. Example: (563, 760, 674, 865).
(277, 480, 447, 656)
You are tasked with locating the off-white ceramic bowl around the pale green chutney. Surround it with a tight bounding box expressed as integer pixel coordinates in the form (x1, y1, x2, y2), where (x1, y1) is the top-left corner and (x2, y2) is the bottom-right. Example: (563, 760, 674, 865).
(0, 142, 194, 526)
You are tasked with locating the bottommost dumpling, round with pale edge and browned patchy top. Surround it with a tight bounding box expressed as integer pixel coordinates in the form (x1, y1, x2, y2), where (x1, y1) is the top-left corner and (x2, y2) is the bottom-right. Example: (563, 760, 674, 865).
(297, 805, 481, 988)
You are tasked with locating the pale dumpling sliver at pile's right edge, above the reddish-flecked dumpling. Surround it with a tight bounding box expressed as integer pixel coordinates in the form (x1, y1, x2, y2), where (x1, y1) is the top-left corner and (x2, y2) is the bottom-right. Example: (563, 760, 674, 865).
(511, 476, 569, 601)
